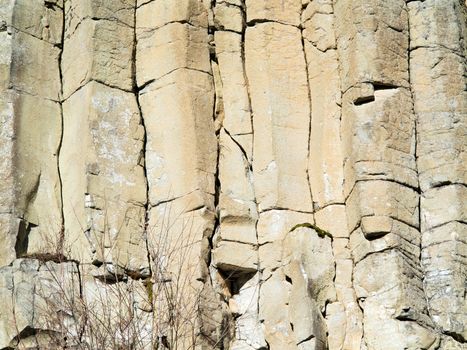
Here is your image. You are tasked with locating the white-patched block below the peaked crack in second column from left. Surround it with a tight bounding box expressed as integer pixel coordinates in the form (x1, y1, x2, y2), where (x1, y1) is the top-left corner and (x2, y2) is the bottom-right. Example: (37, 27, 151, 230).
(60, 82, 147, 271)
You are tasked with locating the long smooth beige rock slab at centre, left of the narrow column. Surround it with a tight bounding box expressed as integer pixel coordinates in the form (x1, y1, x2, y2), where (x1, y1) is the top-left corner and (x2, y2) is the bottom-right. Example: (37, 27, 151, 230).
(245, 23, 312, 211)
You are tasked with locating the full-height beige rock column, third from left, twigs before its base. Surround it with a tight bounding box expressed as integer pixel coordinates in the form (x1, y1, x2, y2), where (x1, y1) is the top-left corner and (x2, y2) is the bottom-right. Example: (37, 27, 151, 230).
(136, 0, 226, 348)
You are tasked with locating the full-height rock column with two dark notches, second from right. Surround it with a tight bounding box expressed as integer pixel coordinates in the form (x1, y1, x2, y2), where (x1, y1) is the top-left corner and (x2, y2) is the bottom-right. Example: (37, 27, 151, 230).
(334, 0, 437, 349)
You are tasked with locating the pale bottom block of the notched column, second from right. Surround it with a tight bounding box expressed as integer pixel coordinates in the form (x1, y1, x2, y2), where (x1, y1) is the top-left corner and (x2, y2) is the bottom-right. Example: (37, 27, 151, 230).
(354, 250, 439, 349)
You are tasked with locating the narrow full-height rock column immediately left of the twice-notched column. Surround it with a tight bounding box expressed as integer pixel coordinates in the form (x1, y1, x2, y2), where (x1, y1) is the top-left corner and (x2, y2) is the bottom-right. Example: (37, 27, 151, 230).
(302, 1, 363, 350)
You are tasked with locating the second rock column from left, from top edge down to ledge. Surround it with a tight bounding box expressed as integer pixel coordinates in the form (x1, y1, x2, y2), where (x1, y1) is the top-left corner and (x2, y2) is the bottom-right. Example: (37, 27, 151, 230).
(60, 0, 149, 276)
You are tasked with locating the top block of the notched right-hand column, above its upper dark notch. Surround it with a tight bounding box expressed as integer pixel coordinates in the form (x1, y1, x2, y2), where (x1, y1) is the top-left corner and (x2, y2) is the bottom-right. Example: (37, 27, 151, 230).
(334, 0, 410, 91)
